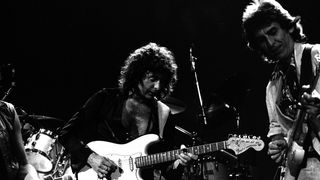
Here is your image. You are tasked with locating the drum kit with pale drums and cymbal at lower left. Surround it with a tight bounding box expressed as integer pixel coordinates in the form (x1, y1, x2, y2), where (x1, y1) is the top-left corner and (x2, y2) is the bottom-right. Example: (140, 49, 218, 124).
(16, 108, 75, 180)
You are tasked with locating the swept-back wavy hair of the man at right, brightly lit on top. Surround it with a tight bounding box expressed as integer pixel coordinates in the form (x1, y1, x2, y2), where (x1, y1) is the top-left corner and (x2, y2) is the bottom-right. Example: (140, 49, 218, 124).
(242, 0, 307, 62)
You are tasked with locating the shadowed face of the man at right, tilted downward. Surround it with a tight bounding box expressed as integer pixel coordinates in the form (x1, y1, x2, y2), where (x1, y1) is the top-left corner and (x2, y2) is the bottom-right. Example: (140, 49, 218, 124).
(255, 22, 294, 60)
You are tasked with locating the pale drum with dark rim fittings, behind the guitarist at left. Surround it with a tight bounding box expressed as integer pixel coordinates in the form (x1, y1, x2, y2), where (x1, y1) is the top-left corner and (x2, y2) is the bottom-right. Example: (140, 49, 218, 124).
(25, 129, 57, 173)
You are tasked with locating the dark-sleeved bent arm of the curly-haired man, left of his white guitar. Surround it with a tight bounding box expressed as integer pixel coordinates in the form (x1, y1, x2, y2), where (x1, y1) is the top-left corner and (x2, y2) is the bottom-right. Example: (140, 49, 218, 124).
(58, 90, 106, 171)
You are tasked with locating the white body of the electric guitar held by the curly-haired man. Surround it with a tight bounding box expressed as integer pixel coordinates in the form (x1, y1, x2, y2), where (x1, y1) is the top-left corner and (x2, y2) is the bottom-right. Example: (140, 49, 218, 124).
(77, 134, 159, 180)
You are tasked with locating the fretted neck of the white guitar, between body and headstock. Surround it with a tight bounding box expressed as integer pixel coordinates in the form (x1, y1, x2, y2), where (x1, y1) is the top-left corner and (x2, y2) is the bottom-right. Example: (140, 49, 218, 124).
(135, 141, 227, 168)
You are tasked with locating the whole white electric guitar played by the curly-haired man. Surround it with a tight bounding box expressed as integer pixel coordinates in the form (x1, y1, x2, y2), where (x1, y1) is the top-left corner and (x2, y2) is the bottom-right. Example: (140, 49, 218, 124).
(77, 134, 264, 180)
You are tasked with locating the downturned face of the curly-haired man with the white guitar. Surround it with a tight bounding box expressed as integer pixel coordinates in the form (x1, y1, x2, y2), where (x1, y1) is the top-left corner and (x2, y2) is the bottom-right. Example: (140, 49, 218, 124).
(138, 72, 162, 100)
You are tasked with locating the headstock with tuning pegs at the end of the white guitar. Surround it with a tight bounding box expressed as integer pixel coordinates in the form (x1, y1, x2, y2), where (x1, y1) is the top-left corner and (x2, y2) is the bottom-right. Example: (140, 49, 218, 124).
(226, 134, 264, 155)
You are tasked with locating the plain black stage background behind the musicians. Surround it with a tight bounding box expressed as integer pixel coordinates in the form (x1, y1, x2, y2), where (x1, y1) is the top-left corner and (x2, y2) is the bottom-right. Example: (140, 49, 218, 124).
(0, 0, 320, 180)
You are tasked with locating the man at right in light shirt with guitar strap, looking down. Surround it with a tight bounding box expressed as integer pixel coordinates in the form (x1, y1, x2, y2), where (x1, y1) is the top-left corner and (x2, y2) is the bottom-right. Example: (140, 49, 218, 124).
(242, 0, 320, 180)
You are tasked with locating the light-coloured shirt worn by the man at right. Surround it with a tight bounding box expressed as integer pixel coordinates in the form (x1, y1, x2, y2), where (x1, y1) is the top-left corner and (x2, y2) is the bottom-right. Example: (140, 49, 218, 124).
(266, 43, 320, 154)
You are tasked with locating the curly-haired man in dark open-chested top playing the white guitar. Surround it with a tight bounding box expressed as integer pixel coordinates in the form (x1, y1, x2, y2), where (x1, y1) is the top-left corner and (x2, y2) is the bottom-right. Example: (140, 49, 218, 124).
(59, 43, 197, 179)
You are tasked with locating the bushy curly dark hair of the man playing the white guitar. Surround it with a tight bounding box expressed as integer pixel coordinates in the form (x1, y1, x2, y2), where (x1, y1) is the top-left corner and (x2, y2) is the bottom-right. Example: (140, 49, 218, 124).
(118, 42, 177, 99)
